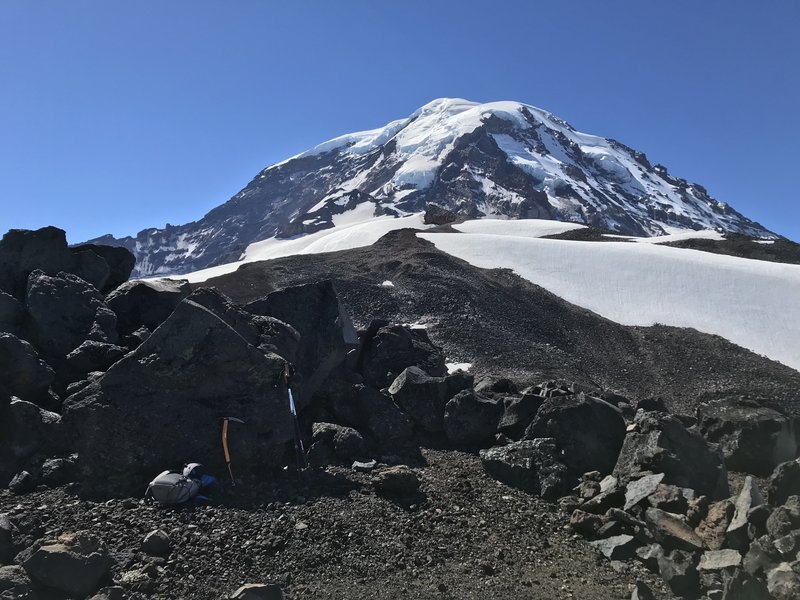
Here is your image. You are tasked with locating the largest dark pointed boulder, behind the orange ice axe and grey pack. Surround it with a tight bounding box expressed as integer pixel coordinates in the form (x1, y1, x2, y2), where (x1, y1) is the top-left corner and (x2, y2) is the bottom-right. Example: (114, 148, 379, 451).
(64, 300, 293, 494)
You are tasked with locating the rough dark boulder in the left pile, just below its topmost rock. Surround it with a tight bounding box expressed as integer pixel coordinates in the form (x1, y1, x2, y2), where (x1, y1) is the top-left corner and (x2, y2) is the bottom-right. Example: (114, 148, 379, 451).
(25, 270, 117, 358)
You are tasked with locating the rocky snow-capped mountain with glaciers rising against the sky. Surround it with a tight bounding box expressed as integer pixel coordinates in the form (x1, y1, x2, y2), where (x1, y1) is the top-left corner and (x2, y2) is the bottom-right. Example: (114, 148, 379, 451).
(92, 98, 776, 277)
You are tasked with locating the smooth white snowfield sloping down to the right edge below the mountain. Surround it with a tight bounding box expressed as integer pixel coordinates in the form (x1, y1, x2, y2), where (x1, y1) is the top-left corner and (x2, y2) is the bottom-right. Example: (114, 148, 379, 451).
(417, 221, 800, 370)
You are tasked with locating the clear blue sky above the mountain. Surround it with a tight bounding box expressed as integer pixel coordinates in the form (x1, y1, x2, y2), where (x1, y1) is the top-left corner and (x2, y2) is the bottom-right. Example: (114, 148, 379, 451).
(0, 0, 800, 242)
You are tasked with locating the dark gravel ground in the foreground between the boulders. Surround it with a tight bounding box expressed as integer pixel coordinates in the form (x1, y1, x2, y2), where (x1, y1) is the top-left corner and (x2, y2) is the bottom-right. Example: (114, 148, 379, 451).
(0, 450, 672, 600)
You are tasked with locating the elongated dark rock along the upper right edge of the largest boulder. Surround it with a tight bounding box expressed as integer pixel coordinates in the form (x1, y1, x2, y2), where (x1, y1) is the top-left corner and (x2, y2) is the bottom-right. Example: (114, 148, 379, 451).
(189, 287, 300, 362)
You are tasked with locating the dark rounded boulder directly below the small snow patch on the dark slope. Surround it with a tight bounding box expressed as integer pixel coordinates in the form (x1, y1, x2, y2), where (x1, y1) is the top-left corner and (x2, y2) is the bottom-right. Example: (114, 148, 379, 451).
(444, 390, 502, 447)
